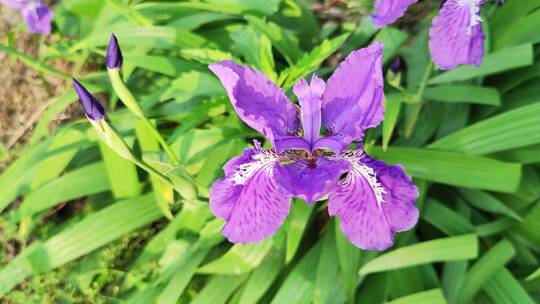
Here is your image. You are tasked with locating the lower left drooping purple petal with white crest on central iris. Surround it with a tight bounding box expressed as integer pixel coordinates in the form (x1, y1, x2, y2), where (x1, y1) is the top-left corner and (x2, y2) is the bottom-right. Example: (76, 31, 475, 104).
(210, 148, 291, 243)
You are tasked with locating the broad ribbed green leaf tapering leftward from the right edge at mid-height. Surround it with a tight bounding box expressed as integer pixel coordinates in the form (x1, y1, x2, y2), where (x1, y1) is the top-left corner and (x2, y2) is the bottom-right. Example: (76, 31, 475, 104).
(429, 103, 540, 154)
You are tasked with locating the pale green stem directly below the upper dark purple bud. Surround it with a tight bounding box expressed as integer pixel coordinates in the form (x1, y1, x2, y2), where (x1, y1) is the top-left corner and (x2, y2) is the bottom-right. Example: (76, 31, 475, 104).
(108, 69, 180, 166)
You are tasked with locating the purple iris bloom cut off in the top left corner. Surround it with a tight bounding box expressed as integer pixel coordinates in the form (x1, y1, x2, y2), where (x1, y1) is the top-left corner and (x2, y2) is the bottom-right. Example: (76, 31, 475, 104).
(0, 0, 53, 35)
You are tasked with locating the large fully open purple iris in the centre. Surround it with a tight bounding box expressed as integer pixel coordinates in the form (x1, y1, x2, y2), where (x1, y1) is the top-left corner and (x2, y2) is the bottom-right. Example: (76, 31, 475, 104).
(210, 42, 418, 250)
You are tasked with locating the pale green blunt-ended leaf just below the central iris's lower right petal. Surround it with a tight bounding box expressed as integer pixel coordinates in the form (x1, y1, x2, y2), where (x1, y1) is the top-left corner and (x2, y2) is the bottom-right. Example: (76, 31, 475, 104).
(360, 234, 478, 276)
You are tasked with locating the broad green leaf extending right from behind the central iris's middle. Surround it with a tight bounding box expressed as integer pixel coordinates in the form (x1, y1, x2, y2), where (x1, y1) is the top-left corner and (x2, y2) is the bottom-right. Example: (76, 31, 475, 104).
(369, 147, 521, 192)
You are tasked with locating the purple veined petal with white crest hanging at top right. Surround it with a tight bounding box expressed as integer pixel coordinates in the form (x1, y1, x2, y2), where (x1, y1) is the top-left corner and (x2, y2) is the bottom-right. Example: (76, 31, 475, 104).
(429, 0, 485, 70)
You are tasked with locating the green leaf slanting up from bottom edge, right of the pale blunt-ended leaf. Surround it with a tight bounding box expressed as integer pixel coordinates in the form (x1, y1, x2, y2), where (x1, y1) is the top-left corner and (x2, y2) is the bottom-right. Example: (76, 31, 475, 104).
(456, 240, 516, 303)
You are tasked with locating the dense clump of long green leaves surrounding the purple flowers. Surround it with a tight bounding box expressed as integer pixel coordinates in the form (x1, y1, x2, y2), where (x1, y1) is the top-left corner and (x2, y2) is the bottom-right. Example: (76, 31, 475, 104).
(0, 0, 540, 304)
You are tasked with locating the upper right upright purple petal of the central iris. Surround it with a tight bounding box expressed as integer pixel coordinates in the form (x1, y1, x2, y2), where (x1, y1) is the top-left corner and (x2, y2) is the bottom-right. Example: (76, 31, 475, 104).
(322, 42, 384, 145)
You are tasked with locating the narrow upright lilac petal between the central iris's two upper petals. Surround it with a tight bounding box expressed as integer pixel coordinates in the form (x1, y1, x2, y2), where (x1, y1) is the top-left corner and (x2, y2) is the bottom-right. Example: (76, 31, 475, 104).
(293, 74, 326, 145)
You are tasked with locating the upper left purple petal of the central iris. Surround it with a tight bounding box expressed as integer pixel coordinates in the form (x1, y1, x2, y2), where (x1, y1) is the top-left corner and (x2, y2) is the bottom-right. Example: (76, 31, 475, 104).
(209, 60, 299, 144)
